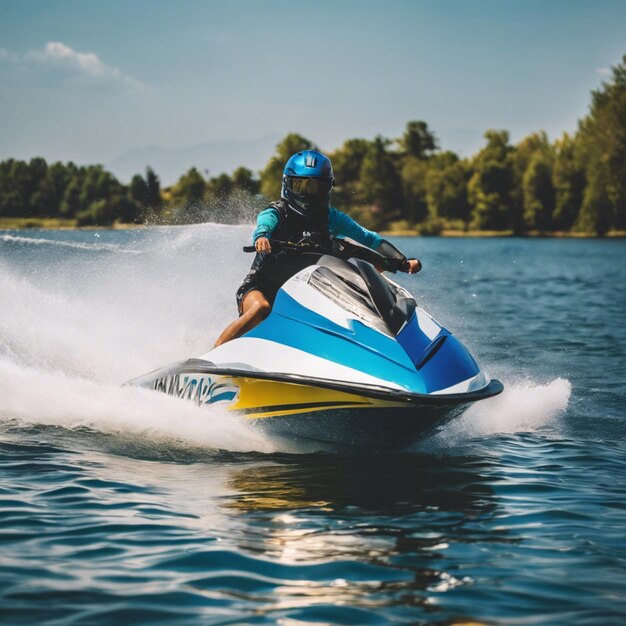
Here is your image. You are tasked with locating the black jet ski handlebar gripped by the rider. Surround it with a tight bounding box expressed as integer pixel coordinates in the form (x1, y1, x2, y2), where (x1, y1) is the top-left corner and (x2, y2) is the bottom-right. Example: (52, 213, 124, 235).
(243, 237, 407, 273)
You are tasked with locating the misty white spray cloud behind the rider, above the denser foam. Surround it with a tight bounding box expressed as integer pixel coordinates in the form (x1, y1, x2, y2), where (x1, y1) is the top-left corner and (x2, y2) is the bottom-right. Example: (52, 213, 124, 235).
(0, 224, 250, 383)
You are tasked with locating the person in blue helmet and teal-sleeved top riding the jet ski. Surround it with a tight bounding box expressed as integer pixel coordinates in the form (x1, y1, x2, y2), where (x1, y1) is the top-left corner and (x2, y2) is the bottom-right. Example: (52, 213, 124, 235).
(215, 150, 422, 346)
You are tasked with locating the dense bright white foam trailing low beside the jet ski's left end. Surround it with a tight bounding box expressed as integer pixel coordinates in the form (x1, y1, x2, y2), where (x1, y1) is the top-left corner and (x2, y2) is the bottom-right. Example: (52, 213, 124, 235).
(0, 360, 275, 452)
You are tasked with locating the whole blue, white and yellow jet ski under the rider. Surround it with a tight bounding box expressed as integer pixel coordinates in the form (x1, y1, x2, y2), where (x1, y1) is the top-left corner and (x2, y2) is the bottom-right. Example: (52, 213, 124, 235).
(127, 239, 503, 450)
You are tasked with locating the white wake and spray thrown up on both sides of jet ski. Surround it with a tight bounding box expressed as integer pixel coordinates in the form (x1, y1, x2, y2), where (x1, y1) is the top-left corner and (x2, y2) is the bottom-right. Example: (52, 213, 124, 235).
(0, 224, 571, 452)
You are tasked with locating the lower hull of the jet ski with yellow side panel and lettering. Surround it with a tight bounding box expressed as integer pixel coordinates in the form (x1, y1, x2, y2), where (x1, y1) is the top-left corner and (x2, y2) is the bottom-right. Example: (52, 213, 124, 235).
(128, 359, 502, 450)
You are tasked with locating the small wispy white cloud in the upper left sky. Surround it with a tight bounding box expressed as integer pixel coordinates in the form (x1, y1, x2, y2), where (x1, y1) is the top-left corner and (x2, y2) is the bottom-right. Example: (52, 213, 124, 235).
(0, 41, 145, 89)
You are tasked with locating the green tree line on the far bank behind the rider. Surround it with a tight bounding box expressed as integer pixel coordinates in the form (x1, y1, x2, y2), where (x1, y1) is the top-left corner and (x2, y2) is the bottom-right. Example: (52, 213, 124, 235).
(0, 55, 626, 235)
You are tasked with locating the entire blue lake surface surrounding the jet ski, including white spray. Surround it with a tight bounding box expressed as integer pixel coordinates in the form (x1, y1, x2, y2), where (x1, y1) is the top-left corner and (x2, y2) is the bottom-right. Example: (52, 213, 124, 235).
(0, 224, 626, 626)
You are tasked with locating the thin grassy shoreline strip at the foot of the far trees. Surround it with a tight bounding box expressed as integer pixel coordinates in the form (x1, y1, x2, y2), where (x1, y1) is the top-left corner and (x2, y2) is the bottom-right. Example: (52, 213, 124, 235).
(0, 217, 626, 239)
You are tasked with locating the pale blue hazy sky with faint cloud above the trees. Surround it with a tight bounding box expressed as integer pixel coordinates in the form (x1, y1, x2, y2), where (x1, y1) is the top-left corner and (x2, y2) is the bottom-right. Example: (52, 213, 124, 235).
(0, 0, 626, 180)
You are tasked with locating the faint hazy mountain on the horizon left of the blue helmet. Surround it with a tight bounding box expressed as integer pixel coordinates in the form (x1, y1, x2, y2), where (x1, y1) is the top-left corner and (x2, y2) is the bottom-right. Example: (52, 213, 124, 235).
(106, 134, 281, 187)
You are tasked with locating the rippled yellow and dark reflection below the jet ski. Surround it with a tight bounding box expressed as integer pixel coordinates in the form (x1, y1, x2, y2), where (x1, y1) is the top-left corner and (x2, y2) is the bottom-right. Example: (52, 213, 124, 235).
(217, 455, 500, 614)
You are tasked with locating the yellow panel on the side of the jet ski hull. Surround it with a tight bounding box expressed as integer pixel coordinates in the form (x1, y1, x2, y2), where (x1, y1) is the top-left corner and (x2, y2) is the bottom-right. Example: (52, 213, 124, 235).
(228, 378, 404, 419)
